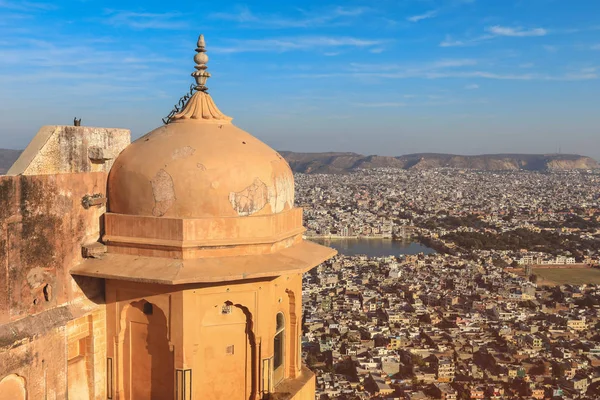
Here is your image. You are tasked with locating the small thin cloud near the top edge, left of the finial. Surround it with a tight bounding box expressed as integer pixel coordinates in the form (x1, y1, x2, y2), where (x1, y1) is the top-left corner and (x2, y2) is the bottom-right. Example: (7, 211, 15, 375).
(102, 10, 189, 30)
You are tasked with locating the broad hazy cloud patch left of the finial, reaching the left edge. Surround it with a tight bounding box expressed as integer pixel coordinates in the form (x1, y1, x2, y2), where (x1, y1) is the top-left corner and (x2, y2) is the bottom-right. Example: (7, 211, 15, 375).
(0, 36, 187, 102)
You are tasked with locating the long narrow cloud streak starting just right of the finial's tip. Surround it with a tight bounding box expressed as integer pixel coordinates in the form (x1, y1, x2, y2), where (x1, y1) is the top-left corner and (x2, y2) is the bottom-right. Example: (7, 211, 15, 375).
(211, 36, 386, 53)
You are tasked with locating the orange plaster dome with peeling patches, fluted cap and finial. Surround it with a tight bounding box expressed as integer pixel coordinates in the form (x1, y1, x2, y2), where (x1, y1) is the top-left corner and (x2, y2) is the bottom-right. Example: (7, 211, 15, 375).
(108, 37, 294, 218)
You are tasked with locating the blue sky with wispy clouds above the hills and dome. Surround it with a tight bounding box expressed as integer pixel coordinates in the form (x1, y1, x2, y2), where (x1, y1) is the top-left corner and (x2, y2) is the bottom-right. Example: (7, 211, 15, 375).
(0, 0, 600, 158)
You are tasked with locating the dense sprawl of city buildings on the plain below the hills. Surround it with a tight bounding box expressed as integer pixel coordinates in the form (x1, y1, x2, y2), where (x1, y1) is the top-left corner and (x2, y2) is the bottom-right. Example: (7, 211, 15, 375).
(296, 169, 600, 399)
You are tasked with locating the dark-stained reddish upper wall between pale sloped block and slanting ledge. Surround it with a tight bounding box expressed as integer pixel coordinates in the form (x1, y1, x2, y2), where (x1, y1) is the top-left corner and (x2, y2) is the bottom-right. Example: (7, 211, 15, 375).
(0, 172, 106, 324)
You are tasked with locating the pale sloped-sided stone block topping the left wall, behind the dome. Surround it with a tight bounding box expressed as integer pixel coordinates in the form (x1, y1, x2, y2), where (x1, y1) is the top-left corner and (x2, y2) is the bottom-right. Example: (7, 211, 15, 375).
(7, 125, 131, 175)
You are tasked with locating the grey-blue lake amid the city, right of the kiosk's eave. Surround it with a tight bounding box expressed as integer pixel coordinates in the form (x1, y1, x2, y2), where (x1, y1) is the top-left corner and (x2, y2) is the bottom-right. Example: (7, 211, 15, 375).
(310, 238, 435, 257)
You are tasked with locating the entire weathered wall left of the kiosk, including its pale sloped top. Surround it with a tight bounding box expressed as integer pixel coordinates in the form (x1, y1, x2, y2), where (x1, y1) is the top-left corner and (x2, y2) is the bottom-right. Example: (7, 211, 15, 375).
(0, 120, 130, 400)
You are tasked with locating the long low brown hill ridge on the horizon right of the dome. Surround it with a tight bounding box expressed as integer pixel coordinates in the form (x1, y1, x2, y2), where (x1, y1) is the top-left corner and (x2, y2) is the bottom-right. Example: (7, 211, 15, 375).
(280, 151, 600, 174)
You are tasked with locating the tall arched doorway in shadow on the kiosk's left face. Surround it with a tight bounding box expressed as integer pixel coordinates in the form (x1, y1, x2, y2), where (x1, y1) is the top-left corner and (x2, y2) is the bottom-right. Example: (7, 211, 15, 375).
(124, 301, 175, 400)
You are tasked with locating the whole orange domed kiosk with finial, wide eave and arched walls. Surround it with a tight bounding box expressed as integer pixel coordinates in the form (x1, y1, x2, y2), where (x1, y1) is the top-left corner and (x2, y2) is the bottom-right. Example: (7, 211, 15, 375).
(72, 36, 335, 400)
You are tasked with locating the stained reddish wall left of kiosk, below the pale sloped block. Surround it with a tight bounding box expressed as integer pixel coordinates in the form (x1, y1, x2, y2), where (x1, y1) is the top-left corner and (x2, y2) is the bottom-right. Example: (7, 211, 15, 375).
(0, 172, 107, 399)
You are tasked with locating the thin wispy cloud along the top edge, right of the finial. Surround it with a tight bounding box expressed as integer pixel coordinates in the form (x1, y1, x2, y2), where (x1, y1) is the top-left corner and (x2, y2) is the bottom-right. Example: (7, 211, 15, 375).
(209, 6, 368, 28)
